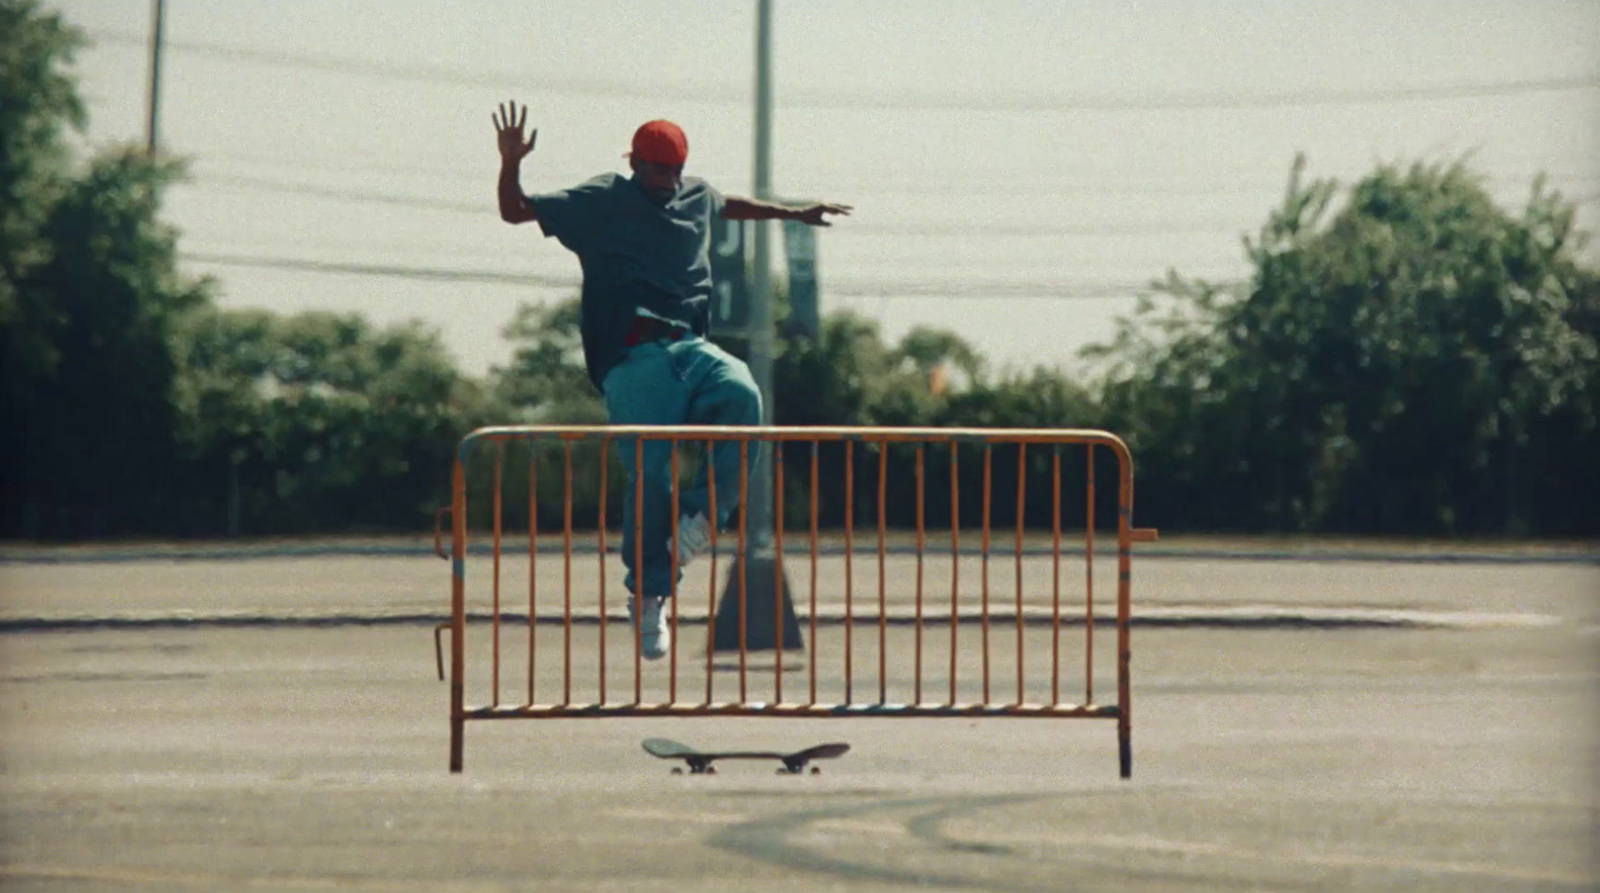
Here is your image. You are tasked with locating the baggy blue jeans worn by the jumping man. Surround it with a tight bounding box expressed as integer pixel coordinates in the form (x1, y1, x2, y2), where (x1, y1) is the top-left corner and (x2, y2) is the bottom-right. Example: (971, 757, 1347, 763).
(605, 338, 762, 595)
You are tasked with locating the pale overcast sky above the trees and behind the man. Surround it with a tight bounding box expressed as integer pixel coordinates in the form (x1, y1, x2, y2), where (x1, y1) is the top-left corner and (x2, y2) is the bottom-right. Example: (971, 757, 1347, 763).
(46, 0, 1600, 373)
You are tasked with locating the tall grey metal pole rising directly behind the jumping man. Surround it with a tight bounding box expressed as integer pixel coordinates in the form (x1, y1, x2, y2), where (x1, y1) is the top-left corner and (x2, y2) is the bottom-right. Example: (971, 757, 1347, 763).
(749, 0, 776, 549)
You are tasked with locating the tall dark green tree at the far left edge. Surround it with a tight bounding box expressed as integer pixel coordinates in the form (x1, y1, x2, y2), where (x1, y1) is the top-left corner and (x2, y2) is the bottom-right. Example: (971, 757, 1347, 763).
(0, 0, 216, 536)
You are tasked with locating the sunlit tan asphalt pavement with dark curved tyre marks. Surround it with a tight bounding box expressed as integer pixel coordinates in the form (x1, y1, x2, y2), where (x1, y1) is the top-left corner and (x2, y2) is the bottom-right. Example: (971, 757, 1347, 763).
(0, 555, 1600, 893)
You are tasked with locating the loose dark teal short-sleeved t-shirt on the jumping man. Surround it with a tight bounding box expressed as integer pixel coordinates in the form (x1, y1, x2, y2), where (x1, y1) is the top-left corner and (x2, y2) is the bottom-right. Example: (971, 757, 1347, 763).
(528, 173, 723, 387)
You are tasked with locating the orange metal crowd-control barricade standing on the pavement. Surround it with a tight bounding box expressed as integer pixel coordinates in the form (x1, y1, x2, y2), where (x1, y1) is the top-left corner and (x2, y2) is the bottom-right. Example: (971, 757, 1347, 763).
(435, 426, 1155, 778)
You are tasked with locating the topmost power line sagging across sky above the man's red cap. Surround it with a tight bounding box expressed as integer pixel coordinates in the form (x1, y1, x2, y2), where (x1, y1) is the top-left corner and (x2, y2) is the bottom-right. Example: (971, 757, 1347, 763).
(88, 29, 1600, 112)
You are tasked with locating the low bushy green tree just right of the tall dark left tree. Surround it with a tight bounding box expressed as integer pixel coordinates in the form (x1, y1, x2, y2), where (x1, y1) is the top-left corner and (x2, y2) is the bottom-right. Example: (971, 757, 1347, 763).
(178, 310, 494, 533)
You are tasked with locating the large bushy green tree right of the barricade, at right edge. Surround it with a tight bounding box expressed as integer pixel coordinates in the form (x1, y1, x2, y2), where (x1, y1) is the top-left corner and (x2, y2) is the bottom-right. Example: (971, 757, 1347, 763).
(1093, 153, 1600, 533)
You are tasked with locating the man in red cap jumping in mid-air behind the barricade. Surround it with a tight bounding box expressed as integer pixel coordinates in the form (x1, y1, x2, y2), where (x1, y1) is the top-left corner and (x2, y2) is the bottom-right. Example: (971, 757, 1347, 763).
(491, 102, 850, 659)
